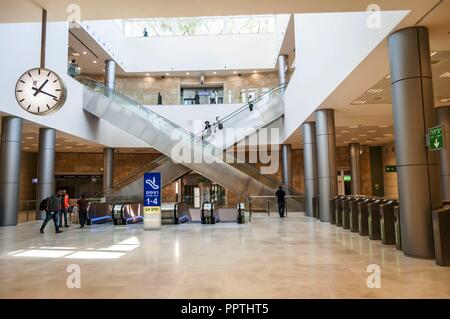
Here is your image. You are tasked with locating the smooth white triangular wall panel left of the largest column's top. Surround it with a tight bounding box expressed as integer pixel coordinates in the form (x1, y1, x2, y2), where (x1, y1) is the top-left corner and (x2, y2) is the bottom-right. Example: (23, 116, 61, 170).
(285, 11, 409, 142)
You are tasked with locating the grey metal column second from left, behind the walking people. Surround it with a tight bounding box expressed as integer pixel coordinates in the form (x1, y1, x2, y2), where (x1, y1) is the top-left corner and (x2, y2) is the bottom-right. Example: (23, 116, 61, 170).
(36, 128, 56, 219)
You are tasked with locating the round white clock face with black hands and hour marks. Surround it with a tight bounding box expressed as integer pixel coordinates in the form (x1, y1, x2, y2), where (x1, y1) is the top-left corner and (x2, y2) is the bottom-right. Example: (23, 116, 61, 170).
(16, 68, 66, 115)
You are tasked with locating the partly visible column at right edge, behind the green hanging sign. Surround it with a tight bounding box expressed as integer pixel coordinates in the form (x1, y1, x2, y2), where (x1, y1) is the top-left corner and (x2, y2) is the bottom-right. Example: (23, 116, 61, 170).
(436, 106, 450, 202)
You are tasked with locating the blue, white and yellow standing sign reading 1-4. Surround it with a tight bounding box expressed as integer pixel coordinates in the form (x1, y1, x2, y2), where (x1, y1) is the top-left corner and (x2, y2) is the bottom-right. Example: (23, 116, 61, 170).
(144, 172, 162, 229)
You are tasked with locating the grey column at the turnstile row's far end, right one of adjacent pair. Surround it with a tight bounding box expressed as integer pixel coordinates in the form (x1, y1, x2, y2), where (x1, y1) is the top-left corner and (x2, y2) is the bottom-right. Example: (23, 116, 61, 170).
(316, 109, 337, 222)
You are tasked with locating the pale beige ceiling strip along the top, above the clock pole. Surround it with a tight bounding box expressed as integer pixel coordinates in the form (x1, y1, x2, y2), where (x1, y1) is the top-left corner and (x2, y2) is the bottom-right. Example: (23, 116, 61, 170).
(0, 0, 438, 22)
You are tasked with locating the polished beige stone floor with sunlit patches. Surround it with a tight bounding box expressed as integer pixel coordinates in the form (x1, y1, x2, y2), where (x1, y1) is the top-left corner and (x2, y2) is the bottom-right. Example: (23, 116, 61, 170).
(0, 214, 450, 298)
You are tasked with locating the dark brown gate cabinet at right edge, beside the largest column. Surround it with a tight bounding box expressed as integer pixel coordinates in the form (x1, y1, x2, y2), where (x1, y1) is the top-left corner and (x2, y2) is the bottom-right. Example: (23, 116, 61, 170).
(433, 206, 450, 266)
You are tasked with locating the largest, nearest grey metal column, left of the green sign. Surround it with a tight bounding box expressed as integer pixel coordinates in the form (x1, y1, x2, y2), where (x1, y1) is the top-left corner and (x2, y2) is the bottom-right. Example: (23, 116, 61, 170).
(389, 27, 441, 258)
